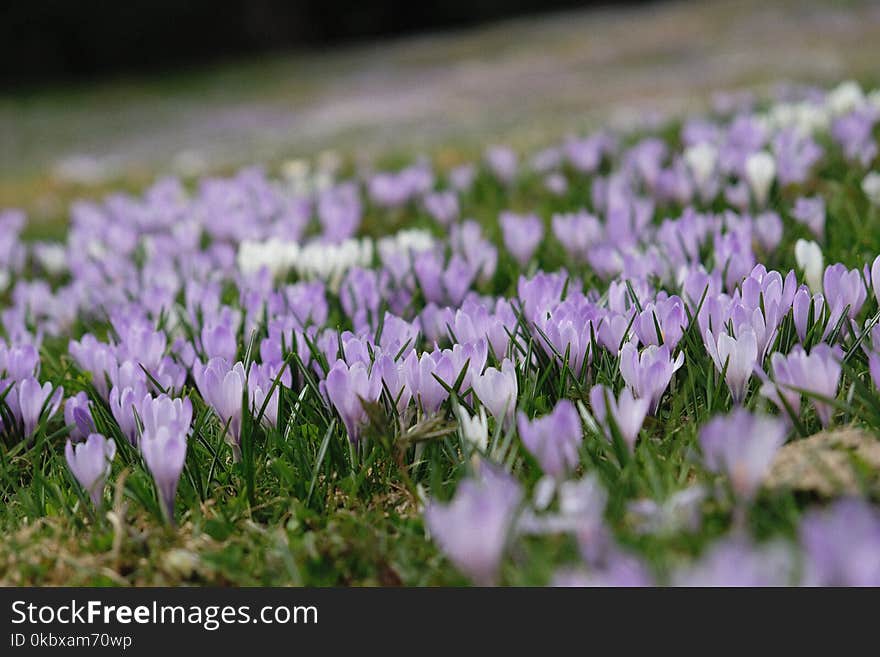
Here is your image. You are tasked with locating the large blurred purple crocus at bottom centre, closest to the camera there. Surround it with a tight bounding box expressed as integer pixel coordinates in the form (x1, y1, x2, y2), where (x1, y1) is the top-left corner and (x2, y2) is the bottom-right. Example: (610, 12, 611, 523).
(425, 465, 522, 586)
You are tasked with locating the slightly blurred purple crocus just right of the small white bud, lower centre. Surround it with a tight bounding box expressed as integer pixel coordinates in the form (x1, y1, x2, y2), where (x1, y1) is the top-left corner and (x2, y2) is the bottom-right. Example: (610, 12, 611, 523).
(517, 399, 583, 478)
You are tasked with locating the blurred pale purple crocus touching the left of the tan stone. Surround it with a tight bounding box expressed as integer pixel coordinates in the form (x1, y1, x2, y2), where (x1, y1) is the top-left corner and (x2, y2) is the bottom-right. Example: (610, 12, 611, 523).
(700, 408, 786, 500)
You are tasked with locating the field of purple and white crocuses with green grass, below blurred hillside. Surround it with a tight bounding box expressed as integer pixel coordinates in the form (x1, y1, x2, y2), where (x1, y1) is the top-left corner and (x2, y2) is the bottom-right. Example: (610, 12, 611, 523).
(0, 82, 880, 586)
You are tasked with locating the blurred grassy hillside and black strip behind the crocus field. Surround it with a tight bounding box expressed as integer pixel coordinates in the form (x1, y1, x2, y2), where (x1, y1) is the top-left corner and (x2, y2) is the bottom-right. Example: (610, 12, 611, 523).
(0, 0, 880, 228)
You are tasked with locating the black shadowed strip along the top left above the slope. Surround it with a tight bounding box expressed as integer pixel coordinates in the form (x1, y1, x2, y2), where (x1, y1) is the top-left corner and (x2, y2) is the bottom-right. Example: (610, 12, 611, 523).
(0, 0, 648, 87)
